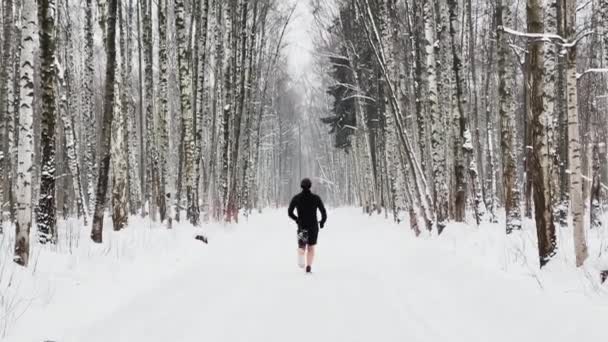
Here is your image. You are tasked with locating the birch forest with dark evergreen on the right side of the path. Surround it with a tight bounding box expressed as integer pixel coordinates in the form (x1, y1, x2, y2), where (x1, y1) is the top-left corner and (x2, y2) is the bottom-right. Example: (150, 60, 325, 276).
(312, 0, 608, 267)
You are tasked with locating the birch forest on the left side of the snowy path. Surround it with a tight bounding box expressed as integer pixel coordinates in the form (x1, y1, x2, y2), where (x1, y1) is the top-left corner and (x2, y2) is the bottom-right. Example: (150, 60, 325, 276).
(0, 0, 304, 265)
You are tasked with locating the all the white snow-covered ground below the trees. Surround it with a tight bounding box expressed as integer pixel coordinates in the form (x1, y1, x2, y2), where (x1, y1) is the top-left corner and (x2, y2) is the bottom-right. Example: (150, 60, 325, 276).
(0, 209, 608, 342)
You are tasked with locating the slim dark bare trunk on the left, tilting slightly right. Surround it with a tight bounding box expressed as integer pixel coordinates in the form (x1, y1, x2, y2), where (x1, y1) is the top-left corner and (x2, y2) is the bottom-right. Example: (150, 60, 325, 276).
(91, 0, 118, 243)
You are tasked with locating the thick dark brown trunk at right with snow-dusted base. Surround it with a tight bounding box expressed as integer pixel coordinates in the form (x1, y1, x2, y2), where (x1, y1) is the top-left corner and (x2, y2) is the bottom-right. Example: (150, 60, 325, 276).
(527, 0, 557, 267)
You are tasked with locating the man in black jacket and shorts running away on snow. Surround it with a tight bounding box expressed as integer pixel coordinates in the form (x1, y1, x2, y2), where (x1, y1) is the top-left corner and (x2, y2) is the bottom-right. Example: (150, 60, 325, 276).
(287, 178, 327, 273)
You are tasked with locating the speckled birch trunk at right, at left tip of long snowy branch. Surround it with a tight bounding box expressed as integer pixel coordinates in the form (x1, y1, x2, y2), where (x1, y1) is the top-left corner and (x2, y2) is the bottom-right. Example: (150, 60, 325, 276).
(496, 0, 521, 234)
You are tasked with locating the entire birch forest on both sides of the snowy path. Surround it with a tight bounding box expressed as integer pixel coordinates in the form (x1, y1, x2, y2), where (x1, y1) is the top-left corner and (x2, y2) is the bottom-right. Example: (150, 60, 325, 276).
(0, 0, 608, 267)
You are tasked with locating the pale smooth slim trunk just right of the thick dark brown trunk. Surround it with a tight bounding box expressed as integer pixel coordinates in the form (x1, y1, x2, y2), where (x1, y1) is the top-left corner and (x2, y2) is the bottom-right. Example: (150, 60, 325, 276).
(565, 1, 588, 266)
